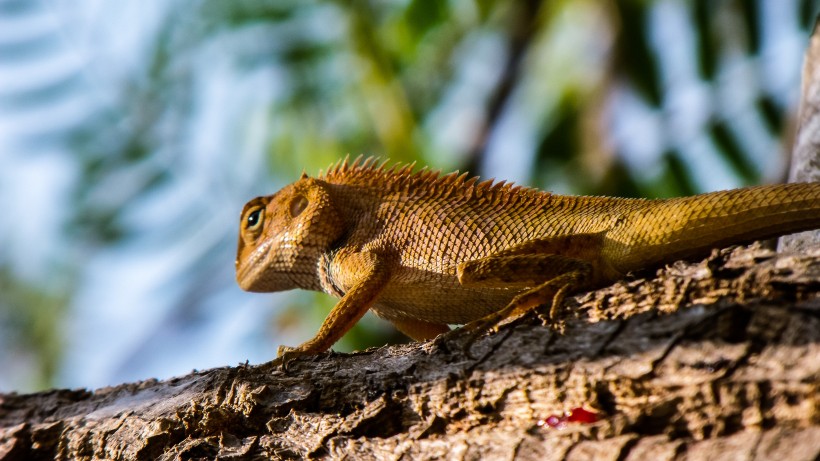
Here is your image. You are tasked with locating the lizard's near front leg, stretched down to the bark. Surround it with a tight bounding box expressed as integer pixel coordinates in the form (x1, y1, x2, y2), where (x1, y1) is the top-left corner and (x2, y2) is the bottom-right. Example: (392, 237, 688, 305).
(278, 252, 390, 368)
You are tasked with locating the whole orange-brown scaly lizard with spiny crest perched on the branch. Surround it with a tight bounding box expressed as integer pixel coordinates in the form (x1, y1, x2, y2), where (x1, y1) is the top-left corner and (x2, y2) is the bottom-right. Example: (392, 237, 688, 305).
(236, 156, 820, 365)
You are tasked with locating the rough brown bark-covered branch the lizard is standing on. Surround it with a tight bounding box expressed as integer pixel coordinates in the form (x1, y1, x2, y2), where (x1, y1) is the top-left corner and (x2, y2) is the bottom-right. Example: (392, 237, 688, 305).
(0, 243, 820, 461)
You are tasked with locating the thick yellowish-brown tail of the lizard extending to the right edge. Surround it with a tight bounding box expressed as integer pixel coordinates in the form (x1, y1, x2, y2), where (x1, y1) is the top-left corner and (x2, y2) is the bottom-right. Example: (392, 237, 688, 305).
(607, 182, 820, 273)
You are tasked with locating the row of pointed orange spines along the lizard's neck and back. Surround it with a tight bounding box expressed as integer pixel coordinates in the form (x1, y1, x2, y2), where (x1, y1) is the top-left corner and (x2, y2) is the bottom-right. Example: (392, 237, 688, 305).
(318, 155, 550, 204)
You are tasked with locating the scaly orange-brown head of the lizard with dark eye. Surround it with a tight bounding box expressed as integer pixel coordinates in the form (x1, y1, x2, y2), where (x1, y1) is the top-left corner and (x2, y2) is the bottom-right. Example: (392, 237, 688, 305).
(236, 176, 343, 292)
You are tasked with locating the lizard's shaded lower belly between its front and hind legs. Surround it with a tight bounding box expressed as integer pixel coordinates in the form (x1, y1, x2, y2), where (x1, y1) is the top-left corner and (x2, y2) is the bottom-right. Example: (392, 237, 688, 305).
(372, 282, 521, 324)
